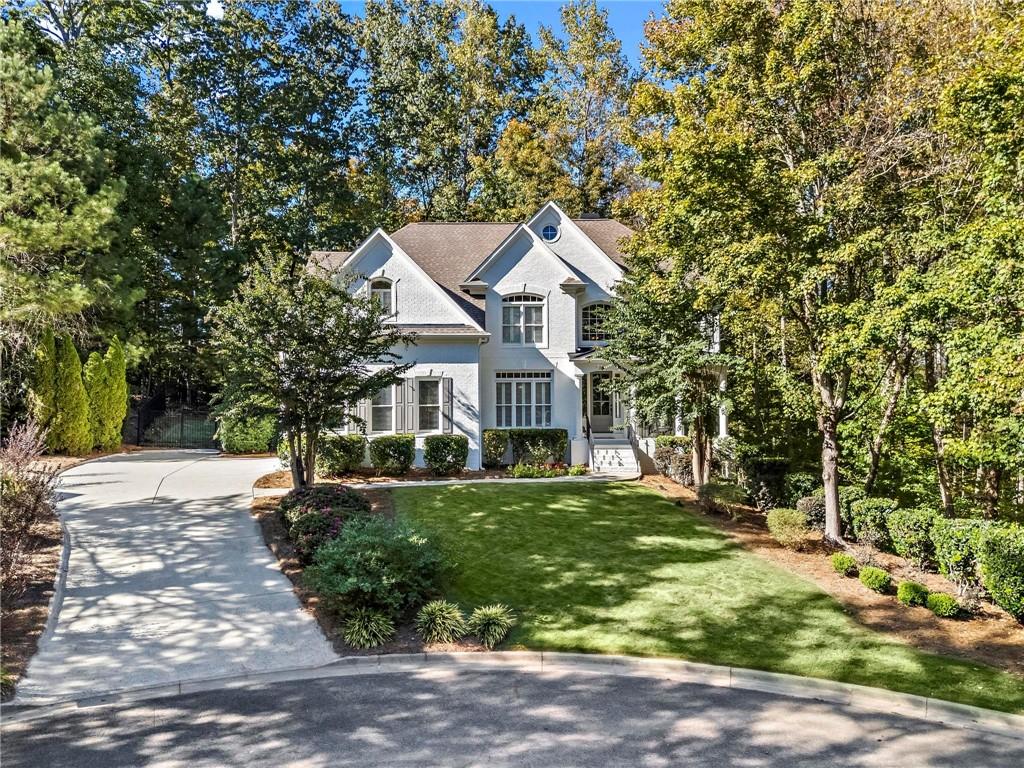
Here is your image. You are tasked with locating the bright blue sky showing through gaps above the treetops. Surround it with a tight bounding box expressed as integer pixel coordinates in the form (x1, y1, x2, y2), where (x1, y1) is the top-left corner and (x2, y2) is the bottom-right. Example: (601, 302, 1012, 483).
(207, 0, 663, 67)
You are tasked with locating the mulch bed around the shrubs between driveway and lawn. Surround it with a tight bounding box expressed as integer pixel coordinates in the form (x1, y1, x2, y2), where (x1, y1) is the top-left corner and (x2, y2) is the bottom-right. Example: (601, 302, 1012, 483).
(252, 489, 484, 656)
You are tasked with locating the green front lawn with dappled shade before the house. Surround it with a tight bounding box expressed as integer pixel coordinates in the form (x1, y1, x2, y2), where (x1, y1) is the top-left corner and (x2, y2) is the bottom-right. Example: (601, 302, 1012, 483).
(392, 483, 1024, 713)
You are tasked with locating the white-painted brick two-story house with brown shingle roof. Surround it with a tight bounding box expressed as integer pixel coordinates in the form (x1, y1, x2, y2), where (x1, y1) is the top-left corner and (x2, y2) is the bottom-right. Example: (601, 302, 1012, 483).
(313, 203, 638, 473)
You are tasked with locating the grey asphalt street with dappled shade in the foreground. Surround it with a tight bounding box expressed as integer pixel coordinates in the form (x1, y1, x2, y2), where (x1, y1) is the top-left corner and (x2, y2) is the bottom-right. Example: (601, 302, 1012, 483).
(3, 669, 1024, 768)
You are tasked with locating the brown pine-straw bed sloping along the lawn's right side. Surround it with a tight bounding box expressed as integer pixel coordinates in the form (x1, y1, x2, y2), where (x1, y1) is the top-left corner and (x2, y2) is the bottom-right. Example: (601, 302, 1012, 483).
(641, 475, 1024, 676)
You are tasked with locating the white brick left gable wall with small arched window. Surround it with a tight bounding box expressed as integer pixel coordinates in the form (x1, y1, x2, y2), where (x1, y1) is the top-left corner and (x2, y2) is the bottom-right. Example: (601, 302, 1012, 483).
(348, 237, 467, 325)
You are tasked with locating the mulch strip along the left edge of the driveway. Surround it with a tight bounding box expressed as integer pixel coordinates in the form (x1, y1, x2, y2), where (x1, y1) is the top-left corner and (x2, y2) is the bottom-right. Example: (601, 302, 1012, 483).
(0, 515, 61, 701)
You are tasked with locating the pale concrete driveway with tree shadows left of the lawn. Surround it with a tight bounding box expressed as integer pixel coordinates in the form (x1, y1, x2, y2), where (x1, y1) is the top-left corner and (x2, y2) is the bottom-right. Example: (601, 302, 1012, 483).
(15, 451, 336, 703)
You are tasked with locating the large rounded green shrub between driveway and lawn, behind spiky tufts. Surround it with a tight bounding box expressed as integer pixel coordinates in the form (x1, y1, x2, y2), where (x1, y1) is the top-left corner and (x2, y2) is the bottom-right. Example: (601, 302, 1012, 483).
(304, 516, 444, 617)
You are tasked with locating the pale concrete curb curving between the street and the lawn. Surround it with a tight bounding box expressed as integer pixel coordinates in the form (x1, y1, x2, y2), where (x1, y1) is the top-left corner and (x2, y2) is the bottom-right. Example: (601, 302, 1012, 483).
(3, 651, 1024, 740)
